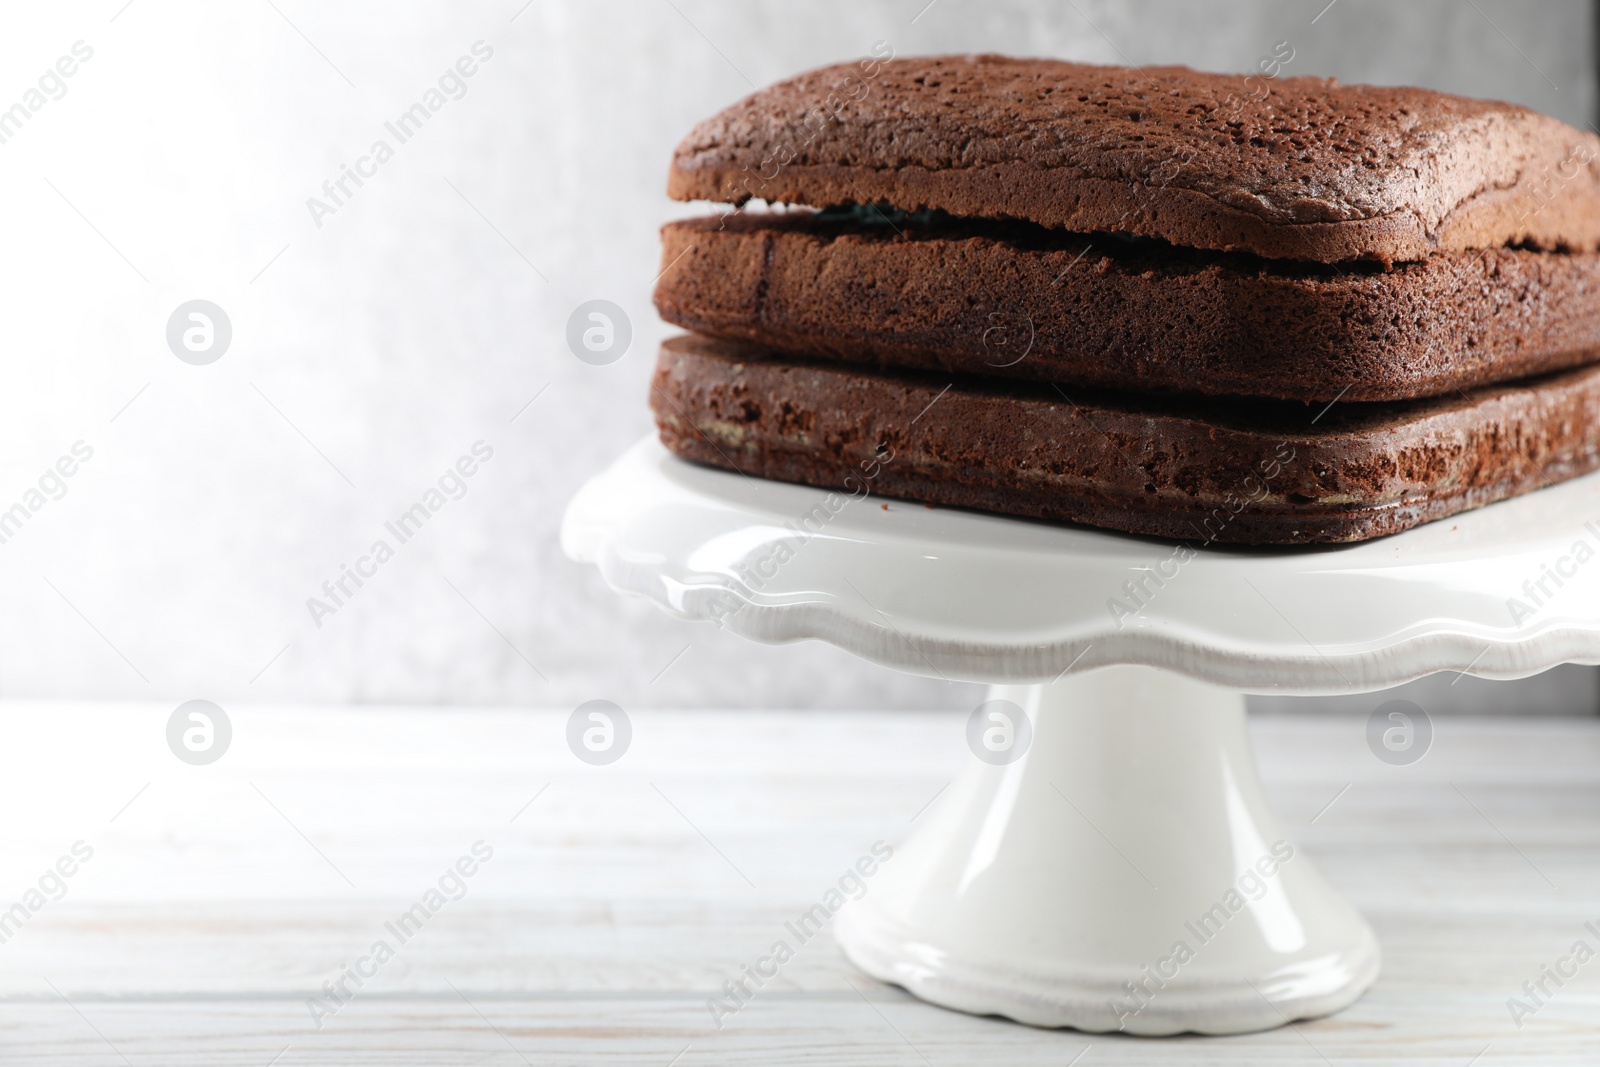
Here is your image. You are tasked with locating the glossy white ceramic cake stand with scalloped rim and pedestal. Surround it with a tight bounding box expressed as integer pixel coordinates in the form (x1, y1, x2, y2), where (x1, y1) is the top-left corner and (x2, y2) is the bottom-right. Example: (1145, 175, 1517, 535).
(562, 440, 1600, 1035)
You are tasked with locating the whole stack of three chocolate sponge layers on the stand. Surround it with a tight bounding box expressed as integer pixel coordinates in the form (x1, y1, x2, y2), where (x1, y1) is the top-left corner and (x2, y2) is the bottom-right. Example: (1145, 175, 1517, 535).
(653, 56, 1600, 544)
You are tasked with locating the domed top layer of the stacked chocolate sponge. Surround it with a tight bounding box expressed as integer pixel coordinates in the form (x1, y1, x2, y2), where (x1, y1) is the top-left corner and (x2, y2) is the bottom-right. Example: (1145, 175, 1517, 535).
(667, 56, 1600, 262)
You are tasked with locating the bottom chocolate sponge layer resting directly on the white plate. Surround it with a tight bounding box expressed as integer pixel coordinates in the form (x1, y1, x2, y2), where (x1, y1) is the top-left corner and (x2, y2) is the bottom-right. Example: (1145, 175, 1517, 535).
(651, 336, 1600, 544)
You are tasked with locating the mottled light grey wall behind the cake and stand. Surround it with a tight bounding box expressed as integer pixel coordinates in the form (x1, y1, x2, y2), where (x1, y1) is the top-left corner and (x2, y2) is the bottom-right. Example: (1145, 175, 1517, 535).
(0, 0, 1595, 707)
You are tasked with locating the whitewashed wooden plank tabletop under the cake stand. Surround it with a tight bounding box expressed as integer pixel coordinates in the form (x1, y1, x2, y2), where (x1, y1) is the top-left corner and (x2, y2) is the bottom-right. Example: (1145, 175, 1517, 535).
(0, 702, 1600, 1067)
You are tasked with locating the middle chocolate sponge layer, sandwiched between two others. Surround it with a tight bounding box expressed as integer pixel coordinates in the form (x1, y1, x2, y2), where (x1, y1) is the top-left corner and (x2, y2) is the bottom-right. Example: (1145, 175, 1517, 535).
(656, 213, 1600, 403)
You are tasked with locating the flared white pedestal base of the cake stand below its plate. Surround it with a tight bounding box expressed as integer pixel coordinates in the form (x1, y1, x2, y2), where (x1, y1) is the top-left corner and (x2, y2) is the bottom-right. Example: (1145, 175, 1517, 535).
(835, 667, 1379, 1035)
